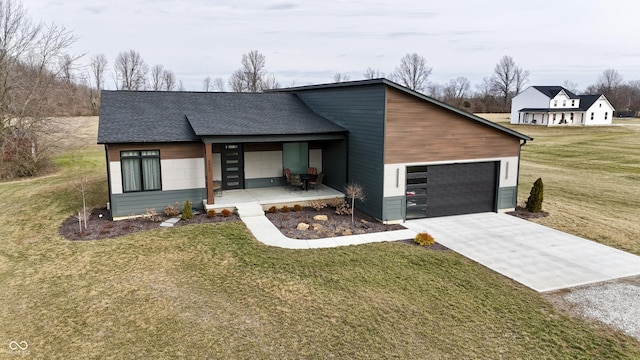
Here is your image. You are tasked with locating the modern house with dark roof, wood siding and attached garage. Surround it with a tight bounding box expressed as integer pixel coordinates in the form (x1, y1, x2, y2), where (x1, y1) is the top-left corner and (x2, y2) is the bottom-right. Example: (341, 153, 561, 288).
(98, 79, 531, 222)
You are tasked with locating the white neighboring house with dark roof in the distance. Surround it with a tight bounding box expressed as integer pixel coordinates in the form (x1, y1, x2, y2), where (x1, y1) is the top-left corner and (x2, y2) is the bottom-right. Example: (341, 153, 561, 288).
(510, 86, 615, 126)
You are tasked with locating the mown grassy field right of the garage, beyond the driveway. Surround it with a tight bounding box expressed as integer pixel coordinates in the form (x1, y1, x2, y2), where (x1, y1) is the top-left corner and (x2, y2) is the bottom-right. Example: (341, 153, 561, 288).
(480, 114, 640, 255)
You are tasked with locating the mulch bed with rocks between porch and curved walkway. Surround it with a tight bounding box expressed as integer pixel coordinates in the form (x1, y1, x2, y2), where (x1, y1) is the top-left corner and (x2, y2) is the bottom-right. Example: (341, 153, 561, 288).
(266, 207, 405, 239)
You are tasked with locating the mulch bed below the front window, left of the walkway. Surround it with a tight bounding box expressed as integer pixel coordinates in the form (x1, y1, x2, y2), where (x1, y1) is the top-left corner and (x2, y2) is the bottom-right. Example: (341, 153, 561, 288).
(58, 209, 240, 240)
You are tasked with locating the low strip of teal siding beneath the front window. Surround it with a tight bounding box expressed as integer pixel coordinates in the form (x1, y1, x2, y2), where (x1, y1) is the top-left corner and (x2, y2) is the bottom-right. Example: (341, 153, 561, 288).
(111, 188, 207, 217)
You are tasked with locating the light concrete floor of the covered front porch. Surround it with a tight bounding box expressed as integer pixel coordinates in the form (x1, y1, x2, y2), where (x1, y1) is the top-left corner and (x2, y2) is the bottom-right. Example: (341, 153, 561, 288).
(203, 186, 344, 211)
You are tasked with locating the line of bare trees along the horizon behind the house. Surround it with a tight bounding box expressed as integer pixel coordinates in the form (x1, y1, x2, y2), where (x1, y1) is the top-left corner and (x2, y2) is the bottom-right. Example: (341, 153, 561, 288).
(0, 0, 640, 179)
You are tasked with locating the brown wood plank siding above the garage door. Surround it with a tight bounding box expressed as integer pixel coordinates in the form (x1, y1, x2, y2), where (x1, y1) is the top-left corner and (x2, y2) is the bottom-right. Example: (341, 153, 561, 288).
(384, 87, 520, 164)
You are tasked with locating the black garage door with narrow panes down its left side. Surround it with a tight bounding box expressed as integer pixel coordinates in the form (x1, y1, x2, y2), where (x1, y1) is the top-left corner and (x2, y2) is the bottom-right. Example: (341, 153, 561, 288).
(406, 161, 498, 219)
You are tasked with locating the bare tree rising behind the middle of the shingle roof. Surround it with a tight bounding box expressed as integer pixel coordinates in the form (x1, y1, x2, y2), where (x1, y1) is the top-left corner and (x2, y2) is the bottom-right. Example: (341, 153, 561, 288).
(229, 50, 277, 92)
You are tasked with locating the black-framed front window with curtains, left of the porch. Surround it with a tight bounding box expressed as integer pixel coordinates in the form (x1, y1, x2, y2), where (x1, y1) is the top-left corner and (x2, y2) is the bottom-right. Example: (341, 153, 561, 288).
(120, 150, 162, 192)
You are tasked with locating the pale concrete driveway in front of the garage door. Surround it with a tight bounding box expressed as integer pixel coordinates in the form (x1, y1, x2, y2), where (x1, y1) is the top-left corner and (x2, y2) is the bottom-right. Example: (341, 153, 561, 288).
(404, 213, 640, 292)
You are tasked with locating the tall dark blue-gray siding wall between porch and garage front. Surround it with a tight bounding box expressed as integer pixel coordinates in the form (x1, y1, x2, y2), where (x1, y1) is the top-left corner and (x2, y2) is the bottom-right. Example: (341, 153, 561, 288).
(297, 84, 385, 219)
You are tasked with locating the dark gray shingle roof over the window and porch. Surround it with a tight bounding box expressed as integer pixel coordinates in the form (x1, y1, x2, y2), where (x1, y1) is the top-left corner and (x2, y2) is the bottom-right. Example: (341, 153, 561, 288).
(98, 91, 346, 143)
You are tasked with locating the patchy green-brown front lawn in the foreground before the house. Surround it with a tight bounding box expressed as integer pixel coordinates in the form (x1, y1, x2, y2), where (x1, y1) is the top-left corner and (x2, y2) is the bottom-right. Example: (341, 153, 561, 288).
(0, 117, 640, 359)
